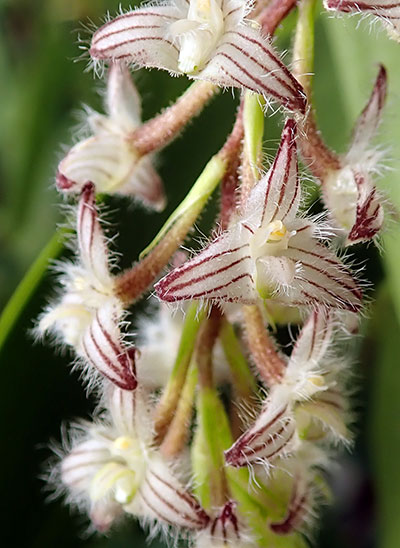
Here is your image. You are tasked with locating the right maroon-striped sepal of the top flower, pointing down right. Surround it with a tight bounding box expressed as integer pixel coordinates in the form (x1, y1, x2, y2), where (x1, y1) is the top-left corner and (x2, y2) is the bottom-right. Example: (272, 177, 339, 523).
(198, 25, 306, 113)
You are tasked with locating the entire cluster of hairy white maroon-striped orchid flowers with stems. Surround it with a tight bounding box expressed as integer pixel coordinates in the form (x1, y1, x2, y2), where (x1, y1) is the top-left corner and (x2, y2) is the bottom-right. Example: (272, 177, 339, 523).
(6, 0, 400, 548)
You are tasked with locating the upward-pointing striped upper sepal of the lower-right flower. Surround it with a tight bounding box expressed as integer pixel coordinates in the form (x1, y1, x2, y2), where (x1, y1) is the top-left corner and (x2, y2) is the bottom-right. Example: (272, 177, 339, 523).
(288, 309, 333, 371)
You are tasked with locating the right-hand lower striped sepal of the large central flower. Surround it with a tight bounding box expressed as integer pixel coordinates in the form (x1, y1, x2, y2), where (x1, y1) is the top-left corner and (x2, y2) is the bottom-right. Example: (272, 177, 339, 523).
(281, 225, 362, 312)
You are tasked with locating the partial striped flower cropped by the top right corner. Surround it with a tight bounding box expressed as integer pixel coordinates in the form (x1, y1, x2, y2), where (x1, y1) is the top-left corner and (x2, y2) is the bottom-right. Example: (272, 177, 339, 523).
(324, 0, 400, 41)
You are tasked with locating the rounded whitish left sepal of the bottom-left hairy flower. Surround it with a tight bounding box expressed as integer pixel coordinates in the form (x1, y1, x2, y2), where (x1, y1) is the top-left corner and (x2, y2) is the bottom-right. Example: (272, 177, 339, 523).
(61, 439, 110, 492)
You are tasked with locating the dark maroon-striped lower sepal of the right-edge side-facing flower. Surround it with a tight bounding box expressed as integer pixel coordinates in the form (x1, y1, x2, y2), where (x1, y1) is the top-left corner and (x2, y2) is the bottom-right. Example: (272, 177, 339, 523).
(347, 173, 384, 244)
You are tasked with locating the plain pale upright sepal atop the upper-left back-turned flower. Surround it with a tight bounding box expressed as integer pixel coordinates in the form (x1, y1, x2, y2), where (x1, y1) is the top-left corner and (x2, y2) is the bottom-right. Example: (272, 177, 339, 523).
(107, 63, 141, 132)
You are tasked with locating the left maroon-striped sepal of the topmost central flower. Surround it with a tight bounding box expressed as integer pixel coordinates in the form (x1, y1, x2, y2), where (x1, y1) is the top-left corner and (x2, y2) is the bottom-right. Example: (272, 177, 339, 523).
(90, 5, 184, 72)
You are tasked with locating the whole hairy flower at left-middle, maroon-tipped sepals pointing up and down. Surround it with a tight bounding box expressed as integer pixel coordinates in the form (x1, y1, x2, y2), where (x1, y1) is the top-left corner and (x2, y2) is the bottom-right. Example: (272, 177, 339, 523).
(38, 184, 136, 390)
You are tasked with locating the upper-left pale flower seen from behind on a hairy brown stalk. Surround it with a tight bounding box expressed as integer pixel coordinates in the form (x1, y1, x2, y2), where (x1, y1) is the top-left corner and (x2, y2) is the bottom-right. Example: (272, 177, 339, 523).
(56, 63, 165, 210)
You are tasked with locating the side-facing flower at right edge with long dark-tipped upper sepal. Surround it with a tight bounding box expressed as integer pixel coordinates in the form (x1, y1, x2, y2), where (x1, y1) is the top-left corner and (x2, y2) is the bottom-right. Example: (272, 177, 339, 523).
(322, 66, 387, 244)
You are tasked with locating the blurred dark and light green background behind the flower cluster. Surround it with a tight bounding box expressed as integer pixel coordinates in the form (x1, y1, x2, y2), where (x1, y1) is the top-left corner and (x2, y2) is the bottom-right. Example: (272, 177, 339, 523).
(0, 0, 400, 548)
